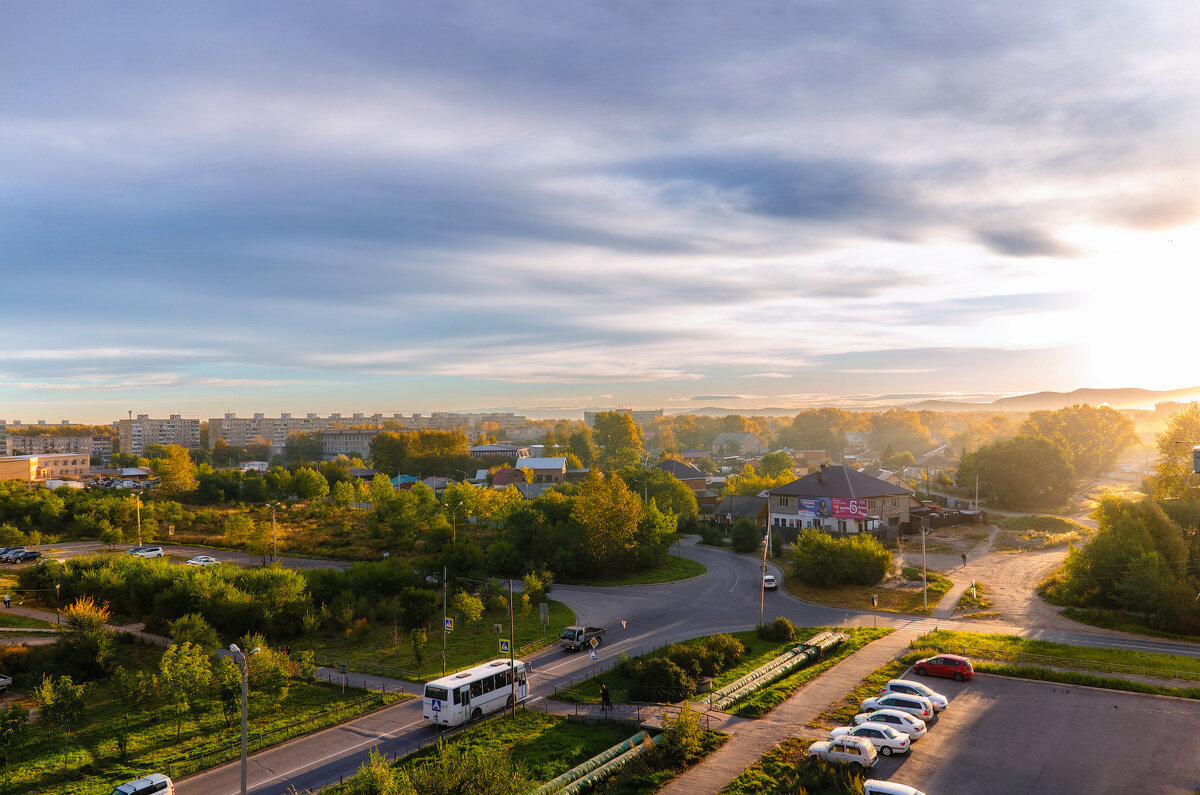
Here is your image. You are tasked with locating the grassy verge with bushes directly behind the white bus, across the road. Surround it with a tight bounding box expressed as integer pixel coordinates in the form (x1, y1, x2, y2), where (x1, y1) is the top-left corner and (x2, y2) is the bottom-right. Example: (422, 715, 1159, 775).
(290, 600, 575, 681)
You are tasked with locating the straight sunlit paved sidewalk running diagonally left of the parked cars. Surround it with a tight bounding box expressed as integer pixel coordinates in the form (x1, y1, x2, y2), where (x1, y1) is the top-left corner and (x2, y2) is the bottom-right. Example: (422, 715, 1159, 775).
(660, 632, 912, 795)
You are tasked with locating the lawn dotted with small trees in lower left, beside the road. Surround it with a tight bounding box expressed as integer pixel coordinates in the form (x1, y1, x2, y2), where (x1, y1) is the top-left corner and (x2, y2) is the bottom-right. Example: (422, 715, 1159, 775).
(8, 662, 395, 795)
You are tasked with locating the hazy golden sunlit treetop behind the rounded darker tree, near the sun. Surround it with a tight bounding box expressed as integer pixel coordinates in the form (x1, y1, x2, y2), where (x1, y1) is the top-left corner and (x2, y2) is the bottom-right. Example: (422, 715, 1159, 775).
(1018, 404, 1138, 474)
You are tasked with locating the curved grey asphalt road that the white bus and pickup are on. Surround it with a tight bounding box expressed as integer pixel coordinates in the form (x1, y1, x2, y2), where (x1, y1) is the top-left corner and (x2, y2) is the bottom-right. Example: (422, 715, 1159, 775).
(175, 540, 1200, 795)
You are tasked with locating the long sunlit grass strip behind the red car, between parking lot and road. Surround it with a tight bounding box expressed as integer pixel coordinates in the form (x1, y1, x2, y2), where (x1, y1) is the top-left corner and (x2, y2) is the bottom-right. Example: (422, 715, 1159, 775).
(913, 629, 1200, 682)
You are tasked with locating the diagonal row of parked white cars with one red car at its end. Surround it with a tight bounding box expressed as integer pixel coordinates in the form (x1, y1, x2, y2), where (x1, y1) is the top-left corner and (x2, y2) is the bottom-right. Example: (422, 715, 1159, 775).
(808, 654, 974, 795)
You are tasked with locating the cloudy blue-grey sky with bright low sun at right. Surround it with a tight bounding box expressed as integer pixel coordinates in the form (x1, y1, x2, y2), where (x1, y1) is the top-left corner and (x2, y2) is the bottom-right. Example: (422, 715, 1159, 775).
(0, 0, 1200, 423)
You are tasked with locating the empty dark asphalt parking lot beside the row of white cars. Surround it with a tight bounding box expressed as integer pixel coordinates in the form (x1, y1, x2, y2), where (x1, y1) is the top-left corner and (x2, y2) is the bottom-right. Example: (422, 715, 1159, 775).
(871, 675, 1200, 795)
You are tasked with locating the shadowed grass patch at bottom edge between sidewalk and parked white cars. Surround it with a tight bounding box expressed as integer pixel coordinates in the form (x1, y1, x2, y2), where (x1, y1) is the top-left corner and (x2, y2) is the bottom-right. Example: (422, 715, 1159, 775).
(721, 737, 865, 795)
